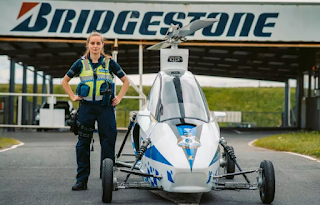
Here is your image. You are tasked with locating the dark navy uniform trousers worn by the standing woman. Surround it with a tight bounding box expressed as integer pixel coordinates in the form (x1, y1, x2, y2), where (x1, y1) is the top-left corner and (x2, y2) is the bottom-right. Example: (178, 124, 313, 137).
(76, 102, 117, 182)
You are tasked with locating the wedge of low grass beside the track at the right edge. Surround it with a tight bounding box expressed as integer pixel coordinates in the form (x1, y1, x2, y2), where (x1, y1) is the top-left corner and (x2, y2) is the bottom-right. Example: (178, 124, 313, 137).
(254, 131, 320, 159)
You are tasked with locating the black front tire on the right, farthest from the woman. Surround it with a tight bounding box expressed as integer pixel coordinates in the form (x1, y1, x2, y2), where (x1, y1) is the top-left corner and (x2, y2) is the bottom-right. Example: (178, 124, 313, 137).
(260, 160, 276, 204)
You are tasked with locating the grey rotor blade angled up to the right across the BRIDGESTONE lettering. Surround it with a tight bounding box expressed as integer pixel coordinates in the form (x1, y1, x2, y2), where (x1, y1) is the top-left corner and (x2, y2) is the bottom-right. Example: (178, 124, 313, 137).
(169, 19, 218, 38)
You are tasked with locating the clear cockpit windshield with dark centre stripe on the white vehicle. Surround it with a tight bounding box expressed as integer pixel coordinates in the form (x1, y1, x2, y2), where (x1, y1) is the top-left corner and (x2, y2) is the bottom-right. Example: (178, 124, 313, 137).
(159, 71, 209, 122)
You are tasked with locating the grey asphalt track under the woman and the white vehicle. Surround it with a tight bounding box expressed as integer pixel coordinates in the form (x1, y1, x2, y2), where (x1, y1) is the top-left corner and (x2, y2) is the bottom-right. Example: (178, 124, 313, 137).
(0, 131, 320, 205)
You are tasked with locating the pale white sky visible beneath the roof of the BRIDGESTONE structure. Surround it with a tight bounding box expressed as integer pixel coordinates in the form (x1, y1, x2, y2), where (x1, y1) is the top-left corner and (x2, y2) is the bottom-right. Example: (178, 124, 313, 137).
(0, 56, 295, 87)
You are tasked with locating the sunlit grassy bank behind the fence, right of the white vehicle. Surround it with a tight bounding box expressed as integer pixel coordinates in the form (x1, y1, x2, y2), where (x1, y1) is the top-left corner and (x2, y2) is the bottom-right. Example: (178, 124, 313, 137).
(203, 87, 295, 127)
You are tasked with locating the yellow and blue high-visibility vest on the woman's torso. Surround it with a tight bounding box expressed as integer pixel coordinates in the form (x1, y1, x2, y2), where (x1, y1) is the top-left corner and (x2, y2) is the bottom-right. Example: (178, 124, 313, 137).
(79, 58, 113, 101)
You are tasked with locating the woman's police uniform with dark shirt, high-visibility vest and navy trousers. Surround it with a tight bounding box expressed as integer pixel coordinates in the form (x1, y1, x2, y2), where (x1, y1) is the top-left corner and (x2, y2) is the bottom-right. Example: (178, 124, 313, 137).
(67, 55, 125, 189)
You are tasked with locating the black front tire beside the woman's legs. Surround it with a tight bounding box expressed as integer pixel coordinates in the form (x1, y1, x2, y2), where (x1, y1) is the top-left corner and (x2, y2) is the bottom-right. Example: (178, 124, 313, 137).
(102, 158, 113, 203)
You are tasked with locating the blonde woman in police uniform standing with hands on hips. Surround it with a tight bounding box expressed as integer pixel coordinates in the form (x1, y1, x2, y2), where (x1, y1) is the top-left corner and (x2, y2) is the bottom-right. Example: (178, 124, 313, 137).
(62, 31, 129, 190)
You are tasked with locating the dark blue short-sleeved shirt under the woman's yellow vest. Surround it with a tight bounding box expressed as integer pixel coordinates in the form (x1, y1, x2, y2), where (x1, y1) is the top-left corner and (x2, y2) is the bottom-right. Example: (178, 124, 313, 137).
(67, 56, 126, 78)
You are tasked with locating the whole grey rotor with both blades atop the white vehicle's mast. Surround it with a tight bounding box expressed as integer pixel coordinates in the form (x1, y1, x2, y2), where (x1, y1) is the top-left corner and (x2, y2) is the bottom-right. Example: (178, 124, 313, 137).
(147, 18, 218, 50)
